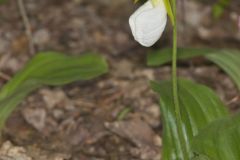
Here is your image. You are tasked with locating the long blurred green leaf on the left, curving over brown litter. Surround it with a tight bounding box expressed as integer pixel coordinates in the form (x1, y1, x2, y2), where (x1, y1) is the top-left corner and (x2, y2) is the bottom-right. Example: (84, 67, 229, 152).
(0, 52, 108, 128)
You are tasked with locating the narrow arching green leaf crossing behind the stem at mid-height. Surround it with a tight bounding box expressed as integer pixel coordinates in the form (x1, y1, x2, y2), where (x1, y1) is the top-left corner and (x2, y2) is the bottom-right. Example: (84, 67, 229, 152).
(147, 48, 240, 90)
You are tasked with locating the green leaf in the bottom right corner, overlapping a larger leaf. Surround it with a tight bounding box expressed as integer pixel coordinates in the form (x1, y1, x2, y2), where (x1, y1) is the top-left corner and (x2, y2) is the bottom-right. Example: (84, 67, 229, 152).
(192, 114, 240, 160)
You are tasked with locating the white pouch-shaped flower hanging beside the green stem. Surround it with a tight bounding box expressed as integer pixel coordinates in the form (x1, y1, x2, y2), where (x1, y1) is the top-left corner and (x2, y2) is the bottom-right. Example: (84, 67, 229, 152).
(129, 0, 167, 47)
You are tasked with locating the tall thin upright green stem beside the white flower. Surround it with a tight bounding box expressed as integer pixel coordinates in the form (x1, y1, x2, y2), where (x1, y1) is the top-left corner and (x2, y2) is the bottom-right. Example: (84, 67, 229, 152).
(172, 0, 189, 160)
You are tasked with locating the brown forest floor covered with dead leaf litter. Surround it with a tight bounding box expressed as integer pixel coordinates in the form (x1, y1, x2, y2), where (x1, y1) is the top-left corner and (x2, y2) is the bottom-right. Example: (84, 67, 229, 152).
(0, 0, 240, 160)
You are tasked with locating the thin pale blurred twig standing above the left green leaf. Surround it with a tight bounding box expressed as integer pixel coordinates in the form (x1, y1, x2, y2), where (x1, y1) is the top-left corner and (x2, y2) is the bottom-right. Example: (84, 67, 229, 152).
(17, 0, 35, 55)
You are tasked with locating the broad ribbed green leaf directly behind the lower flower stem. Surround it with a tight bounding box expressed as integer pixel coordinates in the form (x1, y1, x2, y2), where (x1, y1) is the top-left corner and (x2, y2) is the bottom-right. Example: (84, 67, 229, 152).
(151, 79, 228, 160)
